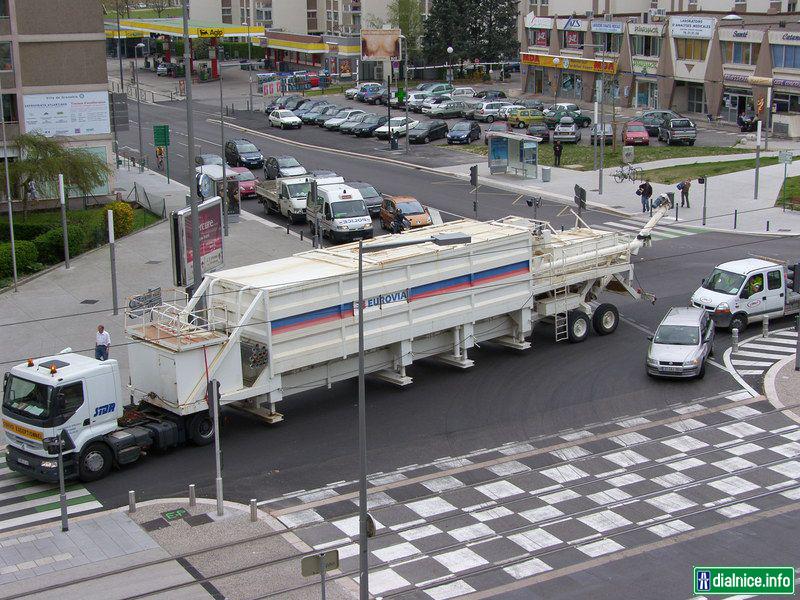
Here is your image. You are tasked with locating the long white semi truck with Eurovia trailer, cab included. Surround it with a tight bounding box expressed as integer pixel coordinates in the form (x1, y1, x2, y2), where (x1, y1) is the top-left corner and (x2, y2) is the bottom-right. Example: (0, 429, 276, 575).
(2, 205, 669, 481)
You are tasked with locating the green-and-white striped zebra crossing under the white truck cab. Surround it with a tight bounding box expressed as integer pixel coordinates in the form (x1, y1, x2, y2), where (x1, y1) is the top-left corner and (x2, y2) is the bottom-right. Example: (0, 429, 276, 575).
(0, 453, 103, 532)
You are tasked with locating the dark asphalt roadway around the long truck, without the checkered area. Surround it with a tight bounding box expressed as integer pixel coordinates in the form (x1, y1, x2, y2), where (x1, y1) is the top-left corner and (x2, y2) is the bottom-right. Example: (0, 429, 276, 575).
(103, 98, 796, 506)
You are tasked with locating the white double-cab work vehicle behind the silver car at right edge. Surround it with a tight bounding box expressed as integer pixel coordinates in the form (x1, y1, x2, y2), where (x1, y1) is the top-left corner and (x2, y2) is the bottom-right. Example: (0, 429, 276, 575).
(692, 258, 800, 331)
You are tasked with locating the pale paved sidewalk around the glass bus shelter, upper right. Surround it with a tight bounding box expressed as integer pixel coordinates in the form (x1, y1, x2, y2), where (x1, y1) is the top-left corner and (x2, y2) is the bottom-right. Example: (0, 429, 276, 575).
(438, 152, 800, 234)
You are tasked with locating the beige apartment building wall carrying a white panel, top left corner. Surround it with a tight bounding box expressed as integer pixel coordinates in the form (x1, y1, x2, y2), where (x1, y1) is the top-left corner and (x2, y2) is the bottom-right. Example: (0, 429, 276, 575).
(0, 0, 114, 195)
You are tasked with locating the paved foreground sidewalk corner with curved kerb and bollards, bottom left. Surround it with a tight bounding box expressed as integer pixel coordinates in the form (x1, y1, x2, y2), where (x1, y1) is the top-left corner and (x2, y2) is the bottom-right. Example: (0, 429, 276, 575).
(0, 499, 358, 600)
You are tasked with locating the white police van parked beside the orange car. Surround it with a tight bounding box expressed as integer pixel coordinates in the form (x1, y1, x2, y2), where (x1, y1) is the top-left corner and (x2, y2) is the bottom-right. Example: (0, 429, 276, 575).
(306, 183, 373, 243)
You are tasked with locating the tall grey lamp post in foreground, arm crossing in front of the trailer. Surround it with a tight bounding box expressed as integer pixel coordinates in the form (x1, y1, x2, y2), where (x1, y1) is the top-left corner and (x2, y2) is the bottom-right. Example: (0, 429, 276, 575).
(358, 233, 472, 600)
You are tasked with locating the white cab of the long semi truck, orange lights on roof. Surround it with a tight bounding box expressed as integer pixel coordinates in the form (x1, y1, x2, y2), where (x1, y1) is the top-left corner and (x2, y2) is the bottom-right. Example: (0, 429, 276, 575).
(3, 353, 123, 481)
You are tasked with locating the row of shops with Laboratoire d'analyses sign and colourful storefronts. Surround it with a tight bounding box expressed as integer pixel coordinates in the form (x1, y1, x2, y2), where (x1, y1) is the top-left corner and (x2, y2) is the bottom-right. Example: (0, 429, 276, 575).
(521, 10, 800, 137)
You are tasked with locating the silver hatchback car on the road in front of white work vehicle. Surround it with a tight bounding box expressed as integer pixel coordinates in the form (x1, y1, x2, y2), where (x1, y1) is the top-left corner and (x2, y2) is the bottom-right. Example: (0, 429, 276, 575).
(647, 307, 714, 378)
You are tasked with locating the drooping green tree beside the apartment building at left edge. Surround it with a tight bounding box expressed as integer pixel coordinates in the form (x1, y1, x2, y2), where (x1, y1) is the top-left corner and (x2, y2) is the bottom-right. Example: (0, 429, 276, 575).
(0, 133, 111, 216)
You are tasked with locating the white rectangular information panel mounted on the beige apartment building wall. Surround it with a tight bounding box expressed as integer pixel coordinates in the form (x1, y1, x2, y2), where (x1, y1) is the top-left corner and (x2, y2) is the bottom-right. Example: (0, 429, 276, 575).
(22, 91, 111, 137)
